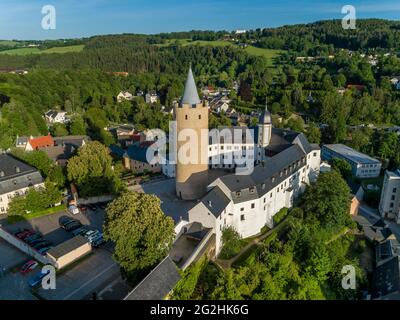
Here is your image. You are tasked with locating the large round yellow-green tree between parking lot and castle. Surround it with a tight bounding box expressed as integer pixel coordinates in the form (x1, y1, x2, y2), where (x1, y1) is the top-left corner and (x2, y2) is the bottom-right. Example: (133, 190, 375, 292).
(104, 191, 175, 272)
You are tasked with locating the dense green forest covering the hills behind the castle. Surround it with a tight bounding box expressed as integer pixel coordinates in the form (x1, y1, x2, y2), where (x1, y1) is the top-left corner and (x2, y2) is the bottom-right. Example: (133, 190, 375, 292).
(0, 19, 400, 164)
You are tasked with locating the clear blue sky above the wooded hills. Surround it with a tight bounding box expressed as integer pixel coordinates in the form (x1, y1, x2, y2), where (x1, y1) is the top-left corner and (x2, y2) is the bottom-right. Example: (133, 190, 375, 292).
(0, 0, 400, 40)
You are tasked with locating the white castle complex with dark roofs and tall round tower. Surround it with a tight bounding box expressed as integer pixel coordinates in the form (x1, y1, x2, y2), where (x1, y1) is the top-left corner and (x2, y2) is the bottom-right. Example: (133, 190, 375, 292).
(175, 69, 321, 254)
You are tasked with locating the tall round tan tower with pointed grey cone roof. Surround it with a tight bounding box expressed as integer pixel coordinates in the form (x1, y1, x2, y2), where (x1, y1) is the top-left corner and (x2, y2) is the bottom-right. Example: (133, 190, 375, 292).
(175, 68, 208, 200)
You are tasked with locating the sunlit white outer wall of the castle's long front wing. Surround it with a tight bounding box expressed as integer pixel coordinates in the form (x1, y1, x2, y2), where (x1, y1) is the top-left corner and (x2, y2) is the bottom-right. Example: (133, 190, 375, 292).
(189, 150, 321, 254)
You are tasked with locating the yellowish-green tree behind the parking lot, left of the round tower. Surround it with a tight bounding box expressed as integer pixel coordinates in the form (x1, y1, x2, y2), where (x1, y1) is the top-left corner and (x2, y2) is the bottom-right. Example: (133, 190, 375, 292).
(67, 141, 122, 196)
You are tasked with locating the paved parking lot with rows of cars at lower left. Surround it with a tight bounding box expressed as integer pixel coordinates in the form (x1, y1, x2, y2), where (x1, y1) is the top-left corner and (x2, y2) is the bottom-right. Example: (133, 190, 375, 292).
(0, 208, 120, 300)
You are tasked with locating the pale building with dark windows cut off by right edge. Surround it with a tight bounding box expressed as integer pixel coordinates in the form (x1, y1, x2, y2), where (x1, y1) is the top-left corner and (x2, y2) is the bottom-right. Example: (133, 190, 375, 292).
(379, 169, 400, 224)
